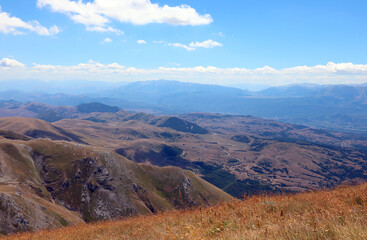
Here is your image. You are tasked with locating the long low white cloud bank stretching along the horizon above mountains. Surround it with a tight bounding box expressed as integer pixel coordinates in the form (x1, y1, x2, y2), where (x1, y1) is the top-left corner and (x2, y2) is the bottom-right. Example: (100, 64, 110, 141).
(0, 58, 367, 86)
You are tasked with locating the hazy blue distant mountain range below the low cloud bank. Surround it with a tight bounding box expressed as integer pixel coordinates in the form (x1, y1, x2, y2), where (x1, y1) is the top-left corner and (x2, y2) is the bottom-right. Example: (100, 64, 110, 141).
(0, 80, 367, 132)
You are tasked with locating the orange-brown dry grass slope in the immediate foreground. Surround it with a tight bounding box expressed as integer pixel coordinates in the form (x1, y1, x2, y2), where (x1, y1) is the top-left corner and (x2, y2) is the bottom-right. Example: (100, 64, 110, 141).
(3, 184, 367, 240)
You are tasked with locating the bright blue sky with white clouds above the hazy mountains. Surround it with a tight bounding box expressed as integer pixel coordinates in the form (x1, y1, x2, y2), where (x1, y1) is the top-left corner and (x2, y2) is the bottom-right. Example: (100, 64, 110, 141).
(0, 0, 367, 85)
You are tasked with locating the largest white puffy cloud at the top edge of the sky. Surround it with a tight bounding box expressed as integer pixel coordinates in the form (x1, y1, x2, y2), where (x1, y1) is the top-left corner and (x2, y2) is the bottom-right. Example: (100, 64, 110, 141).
(37, 0, 213, 32)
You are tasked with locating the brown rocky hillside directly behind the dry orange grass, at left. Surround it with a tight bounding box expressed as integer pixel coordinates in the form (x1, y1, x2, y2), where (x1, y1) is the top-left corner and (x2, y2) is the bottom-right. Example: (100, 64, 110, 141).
(0, 137, 231, 234)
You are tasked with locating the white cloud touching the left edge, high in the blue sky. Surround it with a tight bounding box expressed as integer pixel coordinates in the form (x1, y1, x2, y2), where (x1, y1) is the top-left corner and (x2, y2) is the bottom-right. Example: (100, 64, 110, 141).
(0, 6, 60, 36)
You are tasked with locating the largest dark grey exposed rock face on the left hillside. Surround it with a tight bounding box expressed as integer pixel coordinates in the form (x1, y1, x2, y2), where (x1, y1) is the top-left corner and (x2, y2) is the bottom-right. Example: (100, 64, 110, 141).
(32, 152, 138, 221)
